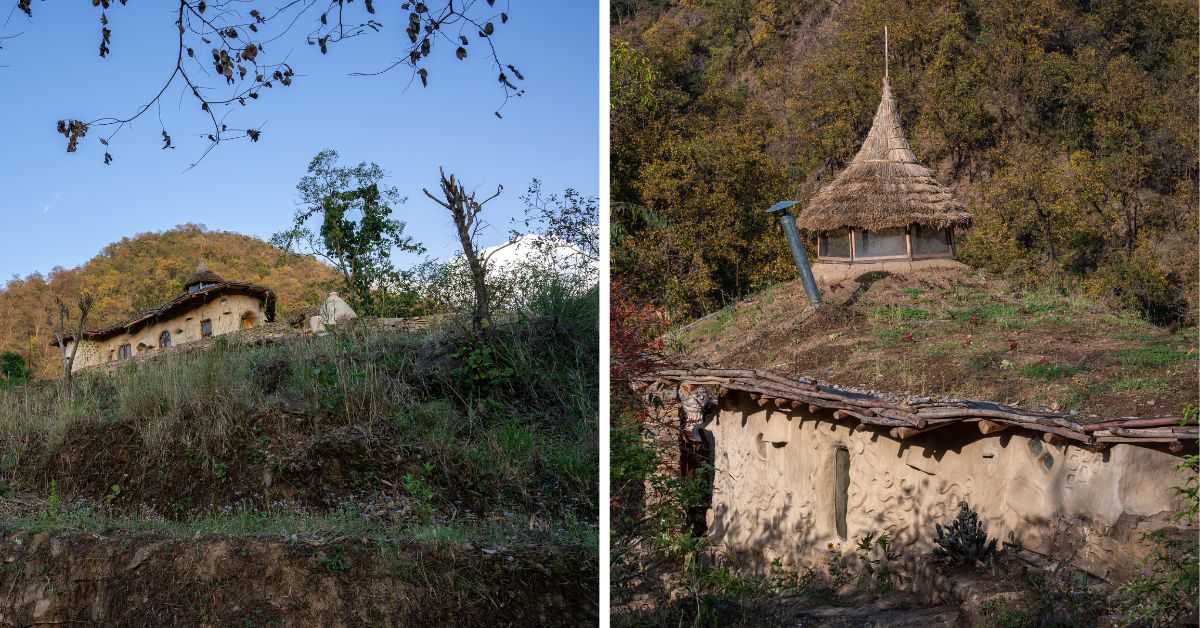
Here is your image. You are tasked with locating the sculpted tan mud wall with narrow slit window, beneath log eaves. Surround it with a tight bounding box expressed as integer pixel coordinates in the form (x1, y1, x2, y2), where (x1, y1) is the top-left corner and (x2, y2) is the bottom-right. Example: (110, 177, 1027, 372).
(706, 393, 1183, 585)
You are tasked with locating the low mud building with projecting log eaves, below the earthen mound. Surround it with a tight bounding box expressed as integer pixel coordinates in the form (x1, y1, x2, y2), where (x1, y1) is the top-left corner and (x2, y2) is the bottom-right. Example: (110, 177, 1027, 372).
(656, 367, 1196, 586)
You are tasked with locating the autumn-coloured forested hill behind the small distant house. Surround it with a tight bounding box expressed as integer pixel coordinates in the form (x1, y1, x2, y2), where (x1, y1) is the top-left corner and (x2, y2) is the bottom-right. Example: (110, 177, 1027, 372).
(0, 225, 336, 376)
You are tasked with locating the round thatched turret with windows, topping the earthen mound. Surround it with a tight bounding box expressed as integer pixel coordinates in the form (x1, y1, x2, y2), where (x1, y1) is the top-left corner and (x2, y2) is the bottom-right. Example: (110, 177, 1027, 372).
(796, 76, 971, 280)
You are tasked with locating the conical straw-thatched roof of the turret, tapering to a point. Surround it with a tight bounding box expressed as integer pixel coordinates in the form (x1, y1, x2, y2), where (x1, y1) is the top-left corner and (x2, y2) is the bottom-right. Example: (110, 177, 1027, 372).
(796, 78, 971, 231)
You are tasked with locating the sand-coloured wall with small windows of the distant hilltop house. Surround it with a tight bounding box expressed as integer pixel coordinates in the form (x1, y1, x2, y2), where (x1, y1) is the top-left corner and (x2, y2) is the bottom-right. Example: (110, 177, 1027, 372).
(67, 294, 266, 371)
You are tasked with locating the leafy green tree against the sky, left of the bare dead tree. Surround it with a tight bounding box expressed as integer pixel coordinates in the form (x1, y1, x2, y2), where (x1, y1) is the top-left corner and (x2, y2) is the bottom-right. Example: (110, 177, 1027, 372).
(271, 149, 425, 316)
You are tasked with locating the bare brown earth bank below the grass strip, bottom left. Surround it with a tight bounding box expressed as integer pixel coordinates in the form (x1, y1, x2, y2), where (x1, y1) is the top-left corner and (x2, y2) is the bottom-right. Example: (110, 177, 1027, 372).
(0, 530, 599, 627)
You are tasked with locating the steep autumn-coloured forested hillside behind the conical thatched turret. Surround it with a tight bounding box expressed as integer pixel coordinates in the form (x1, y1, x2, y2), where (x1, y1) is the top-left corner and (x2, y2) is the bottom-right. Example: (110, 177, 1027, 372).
(611, 0, 1200, 322)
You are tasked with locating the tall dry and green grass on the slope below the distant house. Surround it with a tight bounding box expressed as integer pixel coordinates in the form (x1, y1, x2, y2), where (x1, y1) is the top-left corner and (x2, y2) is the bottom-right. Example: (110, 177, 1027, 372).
(0, 279, 600, 549)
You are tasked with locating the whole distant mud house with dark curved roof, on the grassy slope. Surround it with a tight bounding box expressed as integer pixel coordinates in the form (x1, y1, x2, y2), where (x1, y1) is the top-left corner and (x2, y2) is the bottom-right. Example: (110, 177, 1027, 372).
(54, 267, 275, 371)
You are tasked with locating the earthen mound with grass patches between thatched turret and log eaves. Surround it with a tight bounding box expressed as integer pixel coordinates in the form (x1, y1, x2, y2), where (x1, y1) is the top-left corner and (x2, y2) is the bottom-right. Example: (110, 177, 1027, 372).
(666, 271, 1200, 420)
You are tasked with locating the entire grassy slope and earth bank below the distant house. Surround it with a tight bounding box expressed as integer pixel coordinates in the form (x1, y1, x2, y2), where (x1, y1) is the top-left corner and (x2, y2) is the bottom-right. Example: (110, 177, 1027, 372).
(0, 289, 599, 626)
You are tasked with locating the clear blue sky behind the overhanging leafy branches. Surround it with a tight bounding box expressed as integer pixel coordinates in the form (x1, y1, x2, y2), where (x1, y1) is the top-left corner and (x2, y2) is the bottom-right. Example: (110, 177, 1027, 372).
(0, 0, 599, 282)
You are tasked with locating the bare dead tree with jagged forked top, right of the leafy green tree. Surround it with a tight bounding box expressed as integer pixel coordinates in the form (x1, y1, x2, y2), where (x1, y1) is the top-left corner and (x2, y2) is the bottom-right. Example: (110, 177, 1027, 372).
(421, 168, 512, 335)
